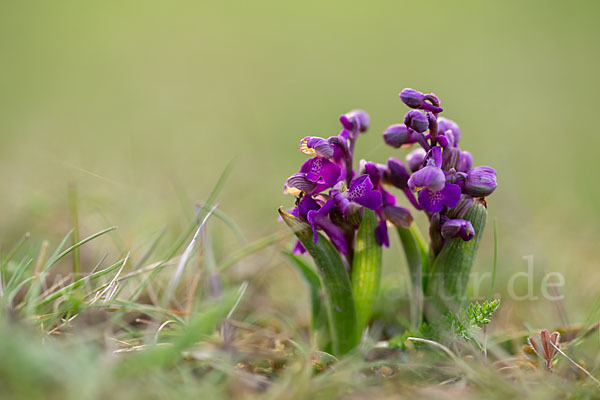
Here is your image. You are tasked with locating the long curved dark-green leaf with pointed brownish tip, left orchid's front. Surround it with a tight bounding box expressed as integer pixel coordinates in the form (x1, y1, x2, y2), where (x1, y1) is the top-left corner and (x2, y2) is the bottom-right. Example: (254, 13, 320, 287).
(279, 209, 360, 356)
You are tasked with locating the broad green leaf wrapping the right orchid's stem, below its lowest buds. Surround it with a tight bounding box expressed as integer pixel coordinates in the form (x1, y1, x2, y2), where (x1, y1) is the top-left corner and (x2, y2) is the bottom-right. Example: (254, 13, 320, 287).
(427, 200, 487, 313)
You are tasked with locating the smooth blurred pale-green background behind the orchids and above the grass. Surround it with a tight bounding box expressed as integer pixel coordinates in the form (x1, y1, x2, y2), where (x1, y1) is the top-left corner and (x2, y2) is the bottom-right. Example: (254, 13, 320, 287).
(0, 0, 600, 325)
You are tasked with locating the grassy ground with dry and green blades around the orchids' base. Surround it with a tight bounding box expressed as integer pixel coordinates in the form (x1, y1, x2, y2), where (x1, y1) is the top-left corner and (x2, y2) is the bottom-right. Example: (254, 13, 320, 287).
(0, 170, 599, 399)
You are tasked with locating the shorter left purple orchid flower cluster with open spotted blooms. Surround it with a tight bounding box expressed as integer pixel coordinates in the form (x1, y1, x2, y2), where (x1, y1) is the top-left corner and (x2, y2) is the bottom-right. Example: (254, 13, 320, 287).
(284, 110, 412, 259)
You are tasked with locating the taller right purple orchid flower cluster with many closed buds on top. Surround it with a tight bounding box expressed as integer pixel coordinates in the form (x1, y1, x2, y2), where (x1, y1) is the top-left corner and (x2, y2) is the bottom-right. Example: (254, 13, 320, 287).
(383, 89, 497, 255)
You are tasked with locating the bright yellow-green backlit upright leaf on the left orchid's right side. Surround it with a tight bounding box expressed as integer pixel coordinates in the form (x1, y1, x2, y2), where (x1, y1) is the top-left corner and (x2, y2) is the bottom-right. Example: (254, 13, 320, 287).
(352, 208, 382, 335)
